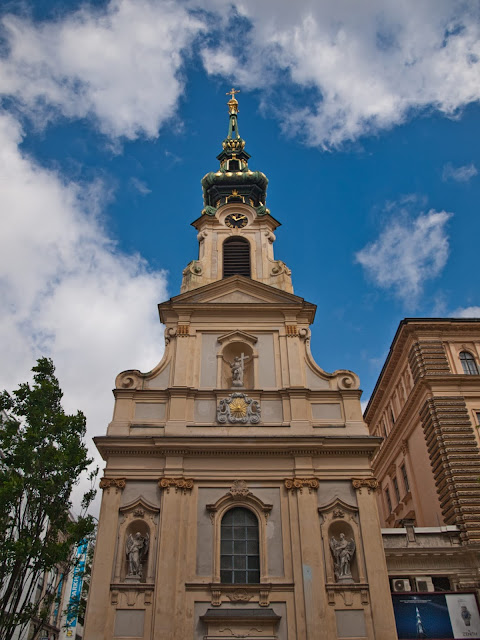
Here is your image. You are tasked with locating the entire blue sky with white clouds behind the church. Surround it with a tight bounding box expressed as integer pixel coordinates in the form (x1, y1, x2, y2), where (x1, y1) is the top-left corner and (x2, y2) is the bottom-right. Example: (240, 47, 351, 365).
(0, 0, 480, 508)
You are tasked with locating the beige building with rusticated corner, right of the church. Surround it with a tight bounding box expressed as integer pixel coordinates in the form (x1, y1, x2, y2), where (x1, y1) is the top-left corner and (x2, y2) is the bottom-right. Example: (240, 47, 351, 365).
(364, 318, 480, 590)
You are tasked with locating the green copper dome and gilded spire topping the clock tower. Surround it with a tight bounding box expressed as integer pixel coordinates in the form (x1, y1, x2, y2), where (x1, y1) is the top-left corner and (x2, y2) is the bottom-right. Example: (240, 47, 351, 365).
(202, 89, 269, 216)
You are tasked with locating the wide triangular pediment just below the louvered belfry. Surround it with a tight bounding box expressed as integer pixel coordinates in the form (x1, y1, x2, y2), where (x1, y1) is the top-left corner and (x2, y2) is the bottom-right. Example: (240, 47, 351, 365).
(165, 276, 313, 306)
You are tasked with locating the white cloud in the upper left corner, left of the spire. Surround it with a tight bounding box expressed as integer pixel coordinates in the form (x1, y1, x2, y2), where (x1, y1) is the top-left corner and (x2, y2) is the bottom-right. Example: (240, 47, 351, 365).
(0, 0, 204, 139)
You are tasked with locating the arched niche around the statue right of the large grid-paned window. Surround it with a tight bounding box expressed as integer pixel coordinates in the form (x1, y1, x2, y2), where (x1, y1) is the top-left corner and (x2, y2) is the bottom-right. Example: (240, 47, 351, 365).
(318, 498, 365, 584)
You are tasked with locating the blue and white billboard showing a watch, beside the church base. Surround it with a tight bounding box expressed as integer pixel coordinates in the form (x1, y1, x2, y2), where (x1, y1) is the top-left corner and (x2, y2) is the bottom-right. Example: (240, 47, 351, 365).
(392, 592, 480, 640)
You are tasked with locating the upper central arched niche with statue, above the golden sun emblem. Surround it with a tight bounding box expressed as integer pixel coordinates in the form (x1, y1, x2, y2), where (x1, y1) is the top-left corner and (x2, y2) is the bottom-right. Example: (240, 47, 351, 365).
(217, 331, 257, 389)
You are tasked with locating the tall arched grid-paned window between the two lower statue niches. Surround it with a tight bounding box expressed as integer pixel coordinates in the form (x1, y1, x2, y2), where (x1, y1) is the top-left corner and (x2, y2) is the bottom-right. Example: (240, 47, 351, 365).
(220, 507, 260, 584)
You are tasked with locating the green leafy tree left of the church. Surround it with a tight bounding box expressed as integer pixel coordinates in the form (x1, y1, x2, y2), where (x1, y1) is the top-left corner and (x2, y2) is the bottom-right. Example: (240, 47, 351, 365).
(0, 358, 96, 640)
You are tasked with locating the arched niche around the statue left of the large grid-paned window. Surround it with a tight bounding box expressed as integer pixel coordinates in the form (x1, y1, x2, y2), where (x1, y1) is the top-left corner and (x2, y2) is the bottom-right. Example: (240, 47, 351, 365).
(113, 497, 160, 584)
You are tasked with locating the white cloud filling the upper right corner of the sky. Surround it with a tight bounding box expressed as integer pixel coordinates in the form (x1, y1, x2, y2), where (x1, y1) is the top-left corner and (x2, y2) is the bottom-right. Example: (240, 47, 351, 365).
(203, 0, 480, 147)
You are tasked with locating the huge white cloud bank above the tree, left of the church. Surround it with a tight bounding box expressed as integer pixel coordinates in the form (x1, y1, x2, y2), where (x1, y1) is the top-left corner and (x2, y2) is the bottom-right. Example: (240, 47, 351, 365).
(0, 115, 166, 516)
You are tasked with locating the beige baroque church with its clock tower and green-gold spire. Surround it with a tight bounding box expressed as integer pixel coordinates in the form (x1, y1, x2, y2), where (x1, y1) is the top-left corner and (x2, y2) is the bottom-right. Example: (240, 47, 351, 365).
(85, 90, 396, 640)
